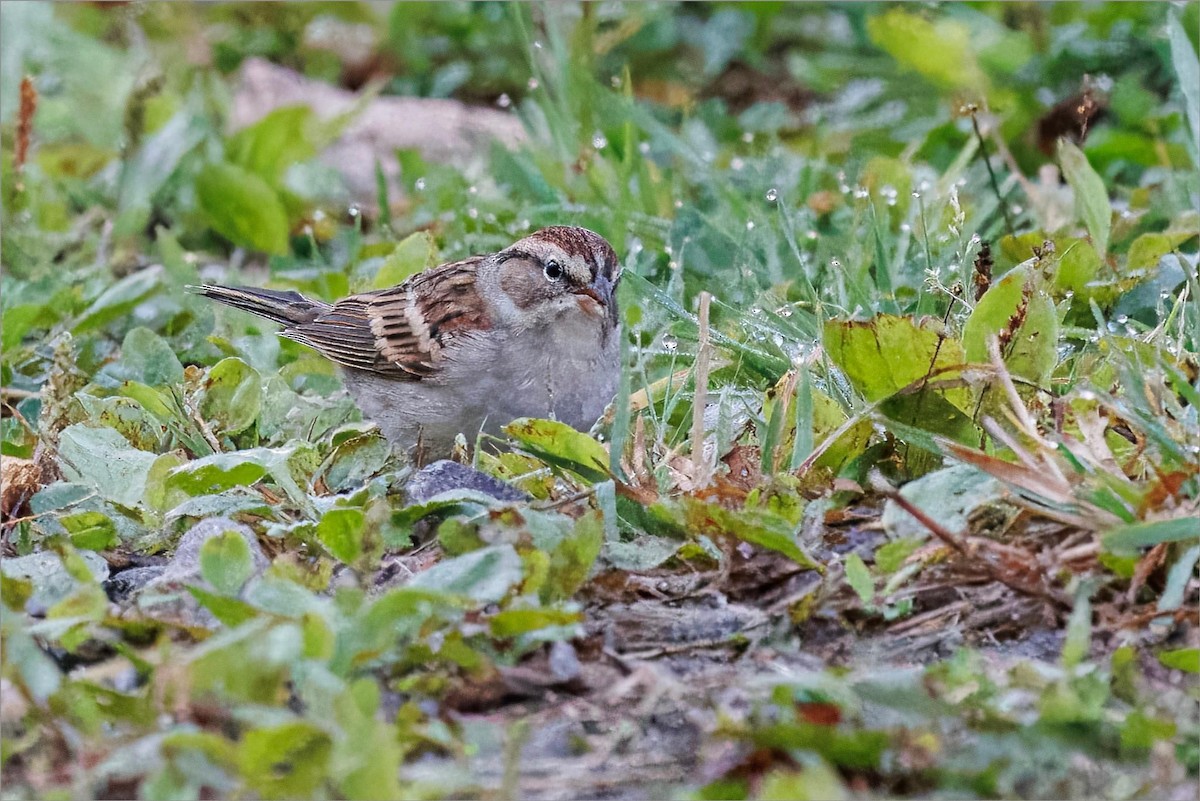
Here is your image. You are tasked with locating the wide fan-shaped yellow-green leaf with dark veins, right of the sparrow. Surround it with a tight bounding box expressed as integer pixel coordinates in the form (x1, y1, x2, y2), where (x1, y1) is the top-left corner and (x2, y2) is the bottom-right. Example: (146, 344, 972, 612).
(823, 314, 970, 410)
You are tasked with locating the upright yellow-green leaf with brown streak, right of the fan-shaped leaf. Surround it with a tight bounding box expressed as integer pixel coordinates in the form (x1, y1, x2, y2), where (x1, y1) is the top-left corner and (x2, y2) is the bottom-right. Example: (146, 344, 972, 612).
(962, 264, 1058, 386)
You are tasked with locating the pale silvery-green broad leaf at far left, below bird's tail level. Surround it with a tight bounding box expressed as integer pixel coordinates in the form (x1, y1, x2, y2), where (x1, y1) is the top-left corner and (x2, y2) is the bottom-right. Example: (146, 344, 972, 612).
(59, 423, 157, 507)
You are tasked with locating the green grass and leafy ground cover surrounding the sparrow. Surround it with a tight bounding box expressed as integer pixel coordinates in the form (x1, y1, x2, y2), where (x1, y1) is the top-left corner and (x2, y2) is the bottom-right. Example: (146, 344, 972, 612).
(0, 2, 1200, 797)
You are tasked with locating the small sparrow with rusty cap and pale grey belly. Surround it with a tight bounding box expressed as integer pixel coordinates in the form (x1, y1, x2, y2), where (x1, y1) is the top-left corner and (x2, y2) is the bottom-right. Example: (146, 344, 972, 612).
(188, 225, 620, 465)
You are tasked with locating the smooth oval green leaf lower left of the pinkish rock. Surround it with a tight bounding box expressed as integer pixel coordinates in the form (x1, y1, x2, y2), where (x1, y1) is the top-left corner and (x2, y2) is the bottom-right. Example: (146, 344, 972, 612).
(196, 164, 288, 255)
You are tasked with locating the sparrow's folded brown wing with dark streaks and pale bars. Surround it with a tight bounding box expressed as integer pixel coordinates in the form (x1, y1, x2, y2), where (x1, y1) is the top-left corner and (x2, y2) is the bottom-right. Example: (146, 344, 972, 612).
(283, 255, 491, 379)
